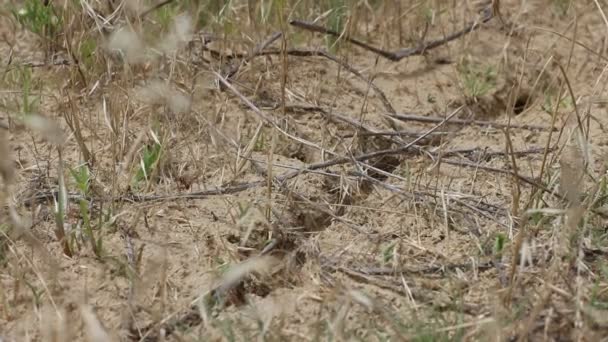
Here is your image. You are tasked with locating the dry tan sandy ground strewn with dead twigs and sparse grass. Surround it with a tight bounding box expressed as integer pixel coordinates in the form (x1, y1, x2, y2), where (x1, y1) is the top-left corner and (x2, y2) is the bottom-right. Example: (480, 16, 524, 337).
(0, 0, 608, 341)
